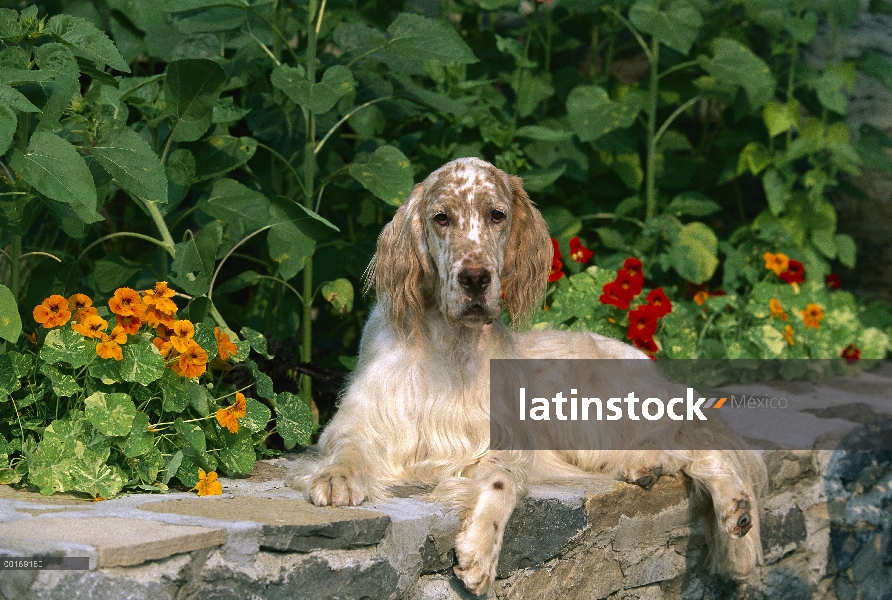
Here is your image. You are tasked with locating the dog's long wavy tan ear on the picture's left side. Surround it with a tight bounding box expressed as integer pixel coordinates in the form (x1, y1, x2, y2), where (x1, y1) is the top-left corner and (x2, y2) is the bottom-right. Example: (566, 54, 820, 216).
(366, 183, 431, 335)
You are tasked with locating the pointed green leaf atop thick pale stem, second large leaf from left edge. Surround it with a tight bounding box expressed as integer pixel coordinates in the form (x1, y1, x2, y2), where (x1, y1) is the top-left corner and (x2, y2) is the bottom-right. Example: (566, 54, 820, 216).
(91, 121, 167, 204)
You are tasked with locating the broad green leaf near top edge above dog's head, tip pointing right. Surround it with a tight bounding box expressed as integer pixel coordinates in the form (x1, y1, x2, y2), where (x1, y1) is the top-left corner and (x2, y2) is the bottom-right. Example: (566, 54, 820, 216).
(385, 13, 477, 64)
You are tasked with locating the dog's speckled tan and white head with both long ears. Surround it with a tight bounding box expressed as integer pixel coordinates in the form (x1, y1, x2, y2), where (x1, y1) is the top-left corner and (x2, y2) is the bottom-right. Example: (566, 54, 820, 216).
(368, 158, 552, 333)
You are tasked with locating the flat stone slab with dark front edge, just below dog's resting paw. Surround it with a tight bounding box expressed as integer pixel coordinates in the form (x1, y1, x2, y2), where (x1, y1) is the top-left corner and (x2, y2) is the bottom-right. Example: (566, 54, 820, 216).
(140, 496, 390, 552)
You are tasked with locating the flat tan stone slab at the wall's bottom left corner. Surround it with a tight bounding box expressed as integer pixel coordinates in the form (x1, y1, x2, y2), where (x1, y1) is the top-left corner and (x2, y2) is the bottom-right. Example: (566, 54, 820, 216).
(0, 517, 226, 568)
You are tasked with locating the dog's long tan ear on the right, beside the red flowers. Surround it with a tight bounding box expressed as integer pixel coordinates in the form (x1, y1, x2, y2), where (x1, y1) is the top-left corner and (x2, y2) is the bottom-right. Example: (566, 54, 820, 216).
(505, 175, 554, 325)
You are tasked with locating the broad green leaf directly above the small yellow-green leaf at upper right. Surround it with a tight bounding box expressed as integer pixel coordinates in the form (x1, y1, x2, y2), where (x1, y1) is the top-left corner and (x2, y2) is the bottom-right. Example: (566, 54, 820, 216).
(701, 38, 775, 110)
